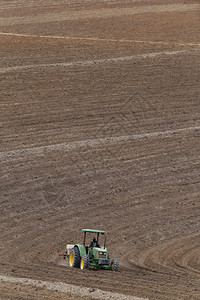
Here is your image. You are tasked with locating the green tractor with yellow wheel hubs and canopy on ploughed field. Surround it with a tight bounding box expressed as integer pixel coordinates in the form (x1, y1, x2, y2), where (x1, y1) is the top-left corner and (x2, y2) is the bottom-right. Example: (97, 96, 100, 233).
(65, 229, 119, 272)
